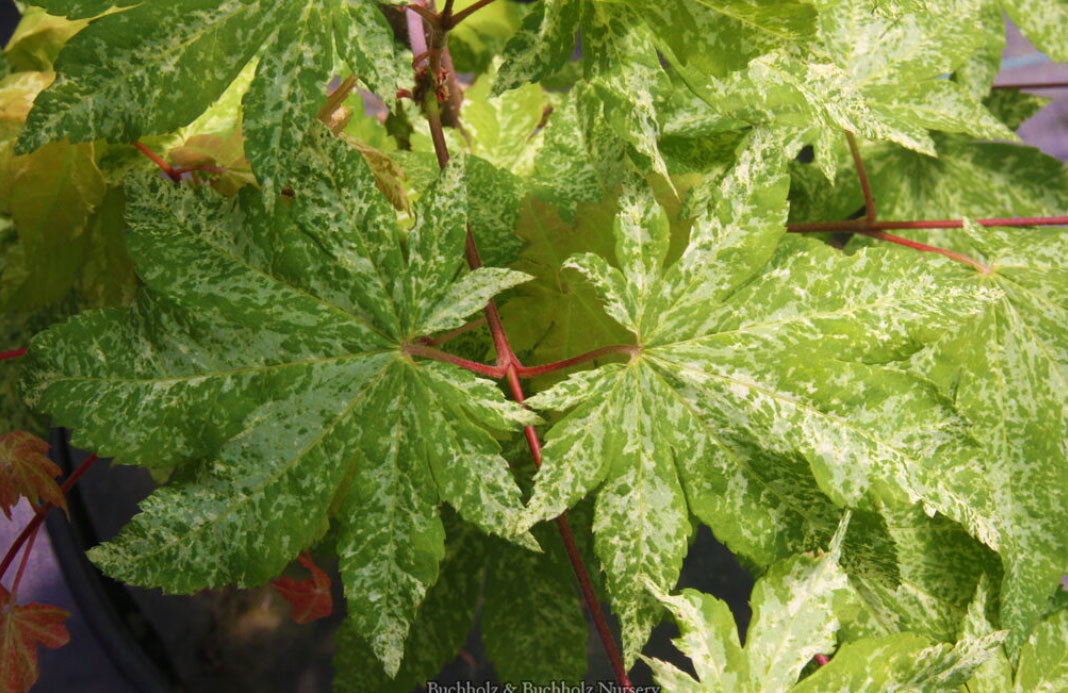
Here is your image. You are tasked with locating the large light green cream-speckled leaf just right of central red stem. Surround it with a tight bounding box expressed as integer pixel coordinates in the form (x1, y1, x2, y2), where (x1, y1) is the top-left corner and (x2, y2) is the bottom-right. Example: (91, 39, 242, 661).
(527, 131, 996, 658)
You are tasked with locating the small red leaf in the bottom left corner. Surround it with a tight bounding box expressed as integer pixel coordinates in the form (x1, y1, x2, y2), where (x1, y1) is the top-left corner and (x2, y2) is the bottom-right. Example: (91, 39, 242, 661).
(0, 586, 70, 693)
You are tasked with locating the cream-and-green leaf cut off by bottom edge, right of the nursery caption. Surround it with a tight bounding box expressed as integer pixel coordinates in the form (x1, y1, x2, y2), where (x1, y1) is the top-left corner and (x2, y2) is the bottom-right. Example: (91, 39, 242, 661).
(646, 518, 1004, 693)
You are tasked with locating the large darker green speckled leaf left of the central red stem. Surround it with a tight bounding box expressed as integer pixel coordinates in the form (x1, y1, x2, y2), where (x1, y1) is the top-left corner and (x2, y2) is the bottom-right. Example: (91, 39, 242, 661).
(26, 128, 536, 674)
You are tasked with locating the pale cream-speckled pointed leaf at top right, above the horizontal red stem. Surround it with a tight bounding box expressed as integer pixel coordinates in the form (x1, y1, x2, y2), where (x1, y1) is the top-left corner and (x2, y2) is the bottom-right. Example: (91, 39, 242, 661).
(682, 0, 1016, 176)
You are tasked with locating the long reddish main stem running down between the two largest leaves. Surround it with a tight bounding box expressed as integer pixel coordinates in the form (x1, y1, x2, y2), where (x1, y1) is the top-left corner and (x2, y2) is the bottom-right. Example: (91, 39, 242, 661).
(408, 6, 631, 691)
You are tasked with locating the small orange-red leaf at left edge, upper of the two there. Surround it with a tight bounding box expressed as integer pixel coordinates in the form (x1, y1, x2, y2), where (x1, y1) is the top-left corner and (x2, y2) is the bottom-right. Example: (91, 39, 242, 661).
(0, 430, 66, 520)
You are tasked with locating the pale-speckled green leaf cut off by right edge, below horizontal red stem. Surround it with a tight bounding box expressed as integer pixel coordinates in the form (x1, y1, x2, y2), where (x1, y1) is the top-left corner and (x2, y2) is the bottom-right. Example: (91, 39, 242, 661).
(915, 225, 1068, 652)
